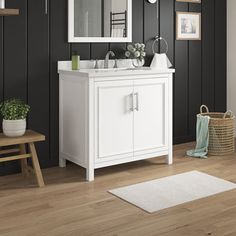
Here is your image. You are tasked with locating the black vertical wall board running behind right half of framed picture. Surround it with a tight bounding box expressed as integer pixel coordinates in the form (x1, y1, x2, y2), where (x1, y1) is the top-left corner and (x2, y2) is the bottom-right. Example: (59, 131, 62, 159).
(188, 4, 202, 139)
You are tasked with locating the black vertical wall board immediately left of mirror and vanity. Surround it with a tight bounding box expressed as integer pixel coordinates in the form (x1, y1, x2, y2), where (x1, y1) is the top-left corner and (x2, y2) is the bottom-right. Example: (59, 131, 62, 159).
(50, 0, 70, 165)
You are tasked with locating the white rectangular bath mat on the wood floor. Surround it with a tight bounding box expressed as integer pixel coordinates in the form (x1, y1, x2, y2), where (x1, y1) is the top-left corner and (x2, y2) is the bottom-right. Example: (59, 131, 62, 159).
(109, 171, 236, 213)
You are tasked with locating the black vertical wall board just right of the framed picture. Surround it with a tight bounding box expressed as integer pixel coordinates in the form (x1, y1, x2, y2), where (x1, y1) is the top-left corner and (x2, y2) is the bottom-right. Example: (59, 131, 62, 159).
(202, 0, 215, 111)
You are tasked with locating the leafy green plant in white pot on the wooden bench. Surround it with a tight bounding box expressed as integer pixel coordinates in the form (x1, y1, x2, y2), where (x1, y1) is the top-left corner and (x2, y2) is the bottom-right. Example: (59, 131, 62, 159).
(0, 99, 30, 137)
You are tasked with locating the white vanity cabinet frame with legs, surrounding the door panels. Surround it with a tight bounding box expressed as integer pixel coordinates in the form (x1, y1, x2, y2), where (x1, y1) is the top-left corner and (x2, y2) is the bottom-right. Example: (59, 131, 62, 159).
(59, 66, 174, 181)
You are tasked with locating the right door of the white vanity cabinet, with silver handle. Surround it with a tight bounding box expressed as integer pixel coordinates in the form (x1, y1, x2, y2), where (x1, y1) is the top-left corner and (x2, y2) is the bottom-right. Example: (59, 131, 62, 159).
(134, 78, 168, 159)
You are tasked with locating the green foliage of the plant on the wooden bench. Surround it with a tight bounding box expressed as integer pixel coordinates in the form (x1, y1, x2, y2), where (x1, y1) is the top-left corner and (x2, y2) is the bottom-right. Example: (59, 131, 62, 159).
(0, 99, 30, 120)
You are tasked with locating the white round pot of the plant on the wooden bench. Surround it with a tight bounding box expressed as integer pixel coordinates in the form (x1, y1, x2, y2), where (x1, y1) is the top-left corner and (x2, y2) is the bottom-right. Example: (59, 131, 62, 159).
(2, 120, 26, 137)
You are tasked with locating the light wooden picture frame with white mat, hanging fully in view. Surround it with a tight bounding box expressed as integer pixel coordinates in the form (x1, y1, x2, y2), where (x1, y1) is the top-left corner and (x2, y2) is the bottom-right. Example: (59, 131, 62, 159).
(176, 11, 201, 40)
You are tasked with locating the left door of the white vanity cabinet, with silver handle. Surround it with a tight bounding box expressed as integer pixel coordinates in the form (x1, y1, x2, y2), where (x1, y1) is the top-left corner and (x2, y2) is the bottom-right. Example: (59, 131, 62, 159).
(95, 81, 134, 164)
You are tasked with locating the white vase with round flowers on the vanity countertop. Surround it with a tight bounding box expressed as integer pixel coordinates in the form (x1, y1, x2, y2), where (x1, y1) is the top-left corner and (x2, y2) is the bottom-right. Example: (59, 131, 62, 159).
(125, 43, 146, 67)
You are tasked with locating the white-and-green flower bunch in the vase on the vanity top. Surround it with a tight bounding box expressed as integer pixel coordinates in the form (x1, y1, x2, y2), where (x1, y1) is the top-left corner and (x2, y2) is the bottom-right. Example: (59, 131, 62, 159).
(125, 43, 146, 61)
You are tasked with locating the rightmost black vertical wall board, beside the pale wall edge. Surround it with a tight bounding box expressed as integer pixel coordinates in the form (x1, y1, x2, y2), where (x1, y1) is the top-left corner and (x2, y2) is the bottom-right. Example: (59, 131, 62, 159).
(214, 0, 227, 111)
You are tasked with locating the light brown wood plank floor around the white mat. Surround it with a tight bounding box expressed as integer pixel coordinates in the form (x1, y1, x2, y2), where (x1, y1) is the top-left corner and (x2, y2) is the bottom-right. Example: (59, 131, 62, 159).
(0, 141, 236, 236)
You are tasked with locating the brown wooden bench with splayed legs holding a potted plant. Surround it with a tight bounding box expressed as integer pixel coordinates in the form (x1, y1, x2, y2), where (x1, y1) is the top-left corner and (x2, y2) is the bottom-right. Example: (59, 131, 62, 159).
(0, 130, 45, 187)
